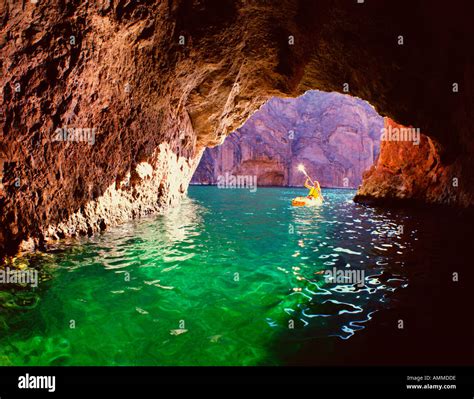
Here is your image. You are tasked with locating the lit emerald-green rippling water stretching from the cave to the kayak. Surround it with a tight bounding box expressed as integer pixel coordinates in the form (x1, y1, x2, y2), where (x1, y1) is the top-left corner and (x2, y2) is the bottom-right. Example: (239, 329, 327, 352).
(0, 187, 409, 365)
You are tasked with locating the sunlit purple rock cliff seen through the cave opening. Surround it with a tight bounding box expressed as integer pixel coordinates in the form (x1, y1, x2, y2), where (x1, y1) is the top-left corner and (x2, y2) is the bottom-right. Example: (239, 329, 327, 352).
(191, 91, 384, 188)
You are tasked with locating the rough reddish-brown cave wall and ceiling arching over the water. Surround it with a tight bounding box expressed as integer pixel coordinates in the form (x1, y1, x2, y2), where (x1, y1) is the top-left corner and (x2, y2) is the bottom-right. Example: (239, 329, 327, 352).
(0, 0, 474, 254)
